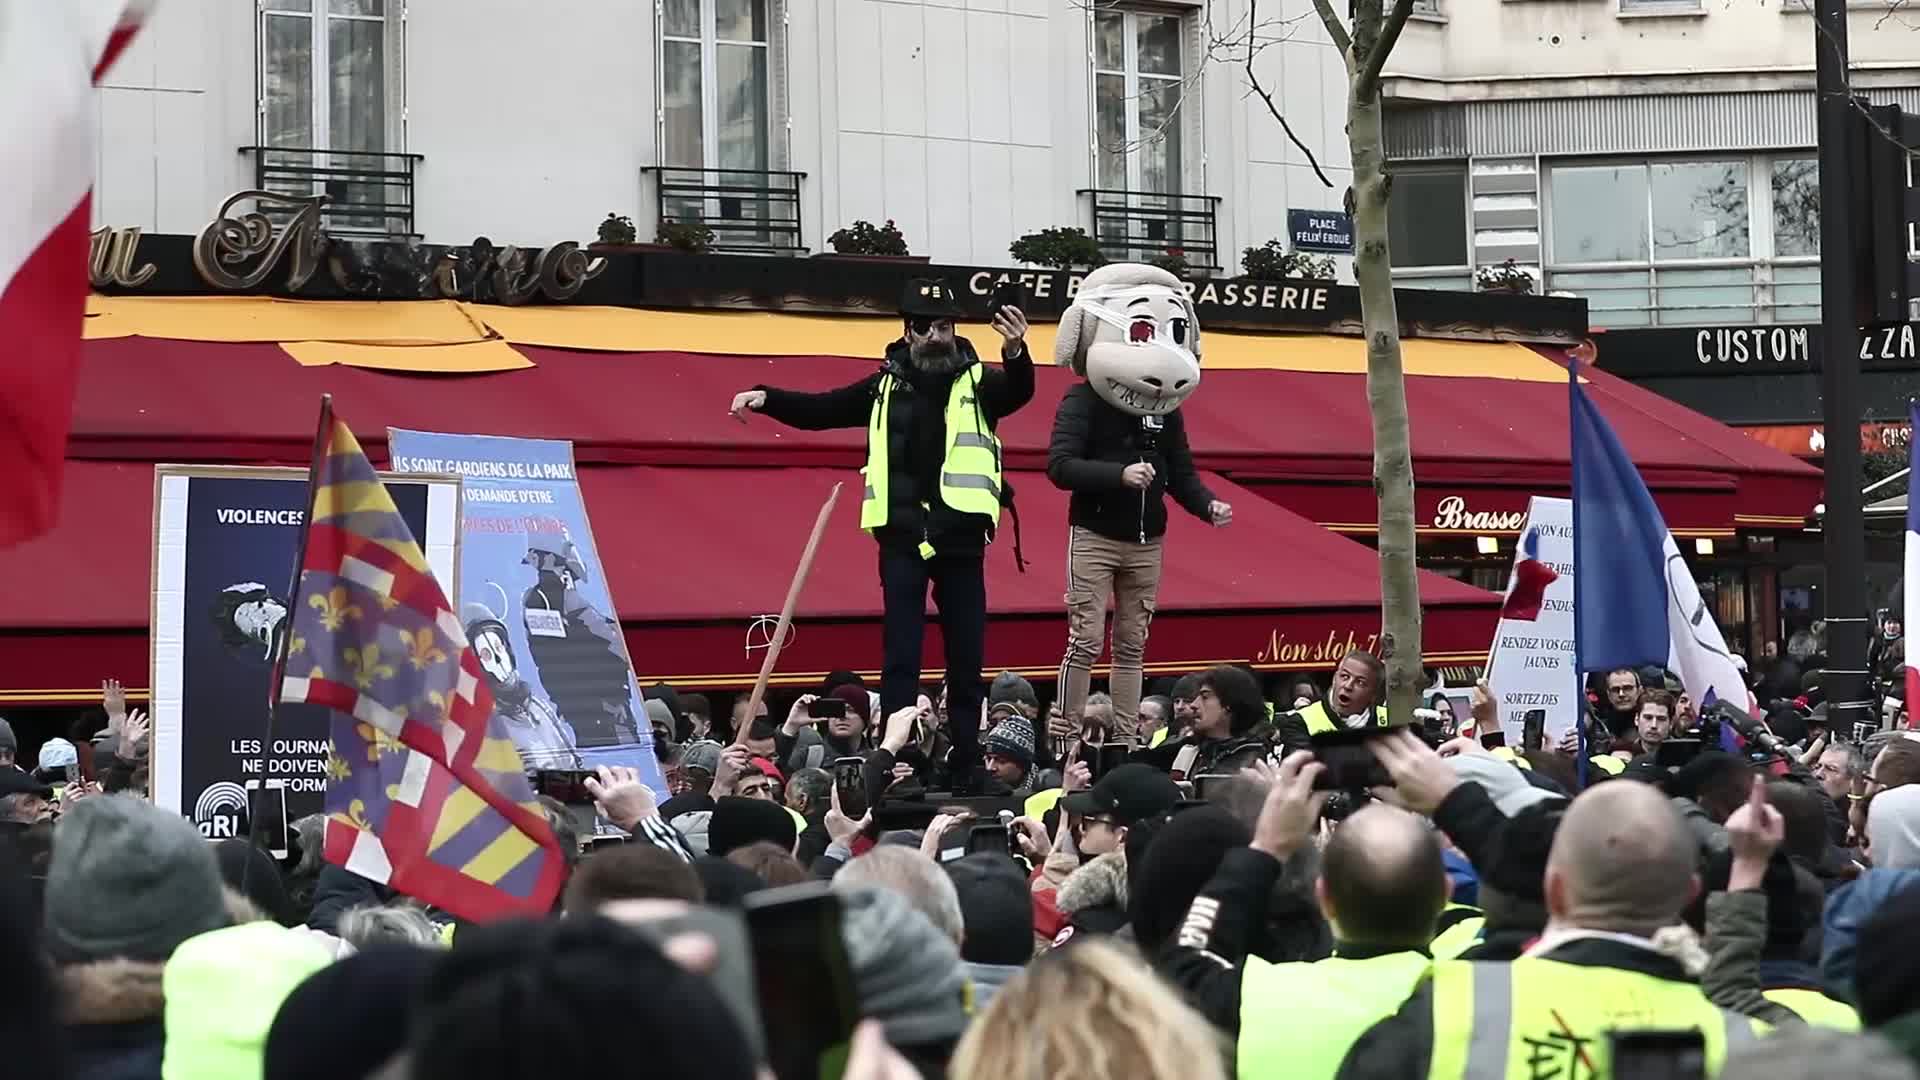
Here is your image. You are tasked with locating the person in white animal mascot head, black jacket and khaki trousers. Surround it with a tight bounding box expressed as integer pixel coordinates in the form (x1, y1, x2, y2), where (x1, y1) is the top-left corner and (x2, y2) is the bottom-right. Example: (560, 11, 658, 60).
(1046, 263, 1233, 740)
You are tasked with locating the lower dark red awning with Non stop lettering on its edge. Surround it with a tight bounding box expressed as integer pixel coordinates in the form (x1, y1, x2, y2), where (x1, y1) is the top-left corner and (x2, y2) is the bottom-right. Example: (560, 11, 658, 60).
(0, 461, 1498, 701)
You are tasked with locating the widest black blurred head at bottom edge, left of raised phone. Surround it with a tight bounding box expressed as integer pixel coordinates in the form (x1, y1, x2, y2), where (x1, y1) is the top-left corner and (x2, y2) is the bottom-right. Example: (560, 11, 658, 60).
(407, 915, 756, 1080)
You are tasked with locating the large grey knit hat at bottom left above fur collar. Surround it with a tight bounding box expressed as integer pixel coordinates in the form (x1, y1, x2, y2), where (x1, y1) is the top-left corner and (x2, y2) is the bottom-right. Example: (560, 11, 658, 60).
(46, 796, 228, 963)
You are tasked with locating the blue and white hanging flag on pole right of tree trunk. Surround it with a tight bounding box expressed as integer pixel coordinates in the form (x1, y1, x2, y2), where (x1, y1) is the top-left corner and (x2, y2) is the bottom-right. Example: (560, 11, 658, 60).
(1569, 373, 1758, 711)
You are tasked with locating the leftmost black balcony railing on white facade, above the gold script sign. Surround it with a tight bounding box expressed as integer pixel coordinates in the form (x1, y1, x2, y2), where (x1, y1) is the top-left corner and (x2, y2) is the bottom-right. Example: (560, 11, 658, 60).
(240, 146, 426, 236)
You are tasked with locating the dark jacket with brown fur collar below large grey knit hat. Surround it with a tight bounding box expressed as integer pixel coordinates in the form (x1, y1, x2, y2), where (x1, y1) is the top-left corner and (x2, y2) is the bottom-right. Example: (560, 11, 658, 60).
(56, 959, 167, 1080)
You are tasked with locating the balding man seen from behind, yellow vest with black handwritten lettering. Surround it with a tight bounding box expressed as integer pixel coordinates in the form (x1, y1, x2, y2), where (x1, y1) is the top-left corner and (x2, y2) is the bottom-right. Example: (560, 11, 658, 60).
(1338, 782, 1764, 1080)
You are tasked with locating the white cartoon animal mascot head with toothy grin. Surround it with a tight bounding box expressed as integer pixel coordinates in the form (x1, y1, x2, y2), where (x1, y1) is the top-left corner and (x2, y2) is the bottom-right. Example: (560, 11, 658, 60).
(1054, 263, 1200, 417)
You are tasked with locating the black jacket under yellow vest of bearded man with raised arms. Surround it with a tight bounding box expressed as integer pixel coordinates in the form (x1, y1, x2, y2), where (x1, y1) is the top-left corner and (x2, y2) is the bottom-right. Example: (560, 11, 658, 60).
(755, 338, 1033, 555)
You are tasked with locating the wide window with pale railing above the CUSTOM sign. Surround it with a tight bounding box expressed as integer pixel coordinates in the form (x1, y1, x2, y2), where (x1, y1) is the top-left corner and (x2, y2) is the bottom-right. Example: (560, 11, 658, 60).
(1546, 156, 1820, 327)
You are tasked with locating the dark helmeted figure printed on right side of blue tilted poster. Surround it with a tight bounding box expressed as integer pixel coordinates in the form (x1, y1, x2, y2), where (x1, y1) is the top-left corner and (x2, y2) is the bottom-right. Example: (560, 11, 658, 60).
(522, 527, 639, 746)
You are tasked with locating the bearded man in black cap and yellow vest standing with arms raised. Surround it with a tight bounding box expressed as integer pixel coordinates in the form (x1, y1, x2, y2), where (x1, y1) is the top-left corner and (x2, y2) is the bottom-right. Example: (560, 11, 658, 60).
(732, 279, 1033, 790)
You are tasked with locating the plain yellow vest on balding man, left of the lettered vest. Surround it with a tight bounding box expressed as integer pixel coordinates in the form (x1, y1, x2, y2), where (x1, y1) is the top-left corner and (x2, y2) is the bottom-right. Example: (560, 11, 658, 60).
(1236, 953, 1430, 1080)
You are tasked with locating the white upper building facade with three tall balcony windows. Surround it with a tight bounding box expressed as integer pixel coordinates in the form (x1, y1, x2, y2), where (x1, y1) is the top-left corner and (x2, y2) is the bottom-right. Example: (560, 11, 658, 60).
(94, 0, 1350, 277)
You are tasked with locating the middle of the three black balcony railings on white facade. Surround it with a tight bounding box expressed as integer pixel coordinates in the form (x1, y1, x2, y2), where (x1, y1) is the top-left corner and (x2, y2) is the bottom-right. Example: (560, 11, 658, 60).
(641, 165, 806, 254)
